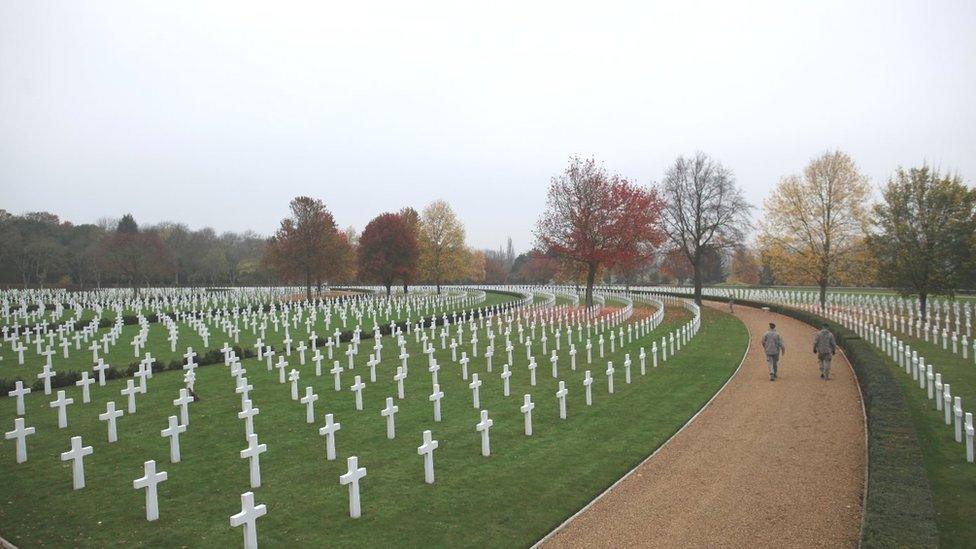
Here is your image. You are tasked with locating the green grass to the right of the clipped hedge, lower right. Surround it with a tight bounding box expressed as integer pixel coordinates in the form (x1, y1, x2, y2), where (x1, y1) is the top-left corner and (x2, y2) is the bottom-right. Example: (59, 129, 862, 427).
(888, 332, 976, 547)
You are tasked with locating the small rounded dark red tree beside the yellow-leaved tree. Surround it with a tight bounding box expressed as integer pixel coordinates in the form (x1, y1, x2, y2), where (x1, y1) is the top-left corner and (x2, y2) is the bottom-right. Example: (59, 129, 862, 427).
(359, 213, 419, 295)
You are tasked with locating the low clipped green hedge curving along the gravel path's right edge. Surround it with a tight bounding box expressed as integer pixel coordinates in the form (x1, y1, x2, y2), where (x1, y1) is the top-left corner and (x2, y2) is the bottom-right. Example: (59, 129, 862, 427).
(632, 290, 939, 547)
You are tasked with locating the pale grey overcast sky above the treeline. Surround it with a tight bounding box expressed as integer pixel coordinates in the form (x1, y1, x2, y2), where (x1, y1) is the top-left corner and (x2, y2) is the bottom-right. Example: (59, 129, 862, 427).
(0, 0, 976, 249)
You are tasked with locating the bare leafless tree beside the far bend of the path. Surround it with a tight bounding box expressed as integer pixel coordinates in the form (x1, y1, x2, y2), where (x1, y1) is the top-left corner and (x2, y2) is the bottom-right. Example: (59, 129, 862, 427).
(661, 152, 752, 305)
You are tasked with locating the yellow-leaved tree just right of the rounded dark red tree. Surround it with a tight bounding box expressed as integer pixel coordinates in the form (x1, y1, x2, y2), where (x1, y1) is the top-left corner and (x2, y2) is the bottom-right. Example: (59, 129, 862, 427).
(419, 200, 467, 293)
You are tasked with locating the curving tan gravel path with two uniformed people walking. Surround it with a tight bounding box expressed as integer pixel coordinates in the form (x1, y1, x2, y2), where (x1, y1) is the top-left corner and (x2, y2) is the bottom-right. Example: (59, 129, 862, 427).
(543, 305, 864, 547)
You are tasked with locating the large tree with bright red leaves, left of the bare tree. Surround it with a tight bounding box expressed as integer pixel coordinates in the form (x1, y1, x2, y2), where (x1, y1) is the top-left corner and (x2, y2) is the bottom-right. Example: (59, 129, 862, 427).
(535, 157, 662, 307)
